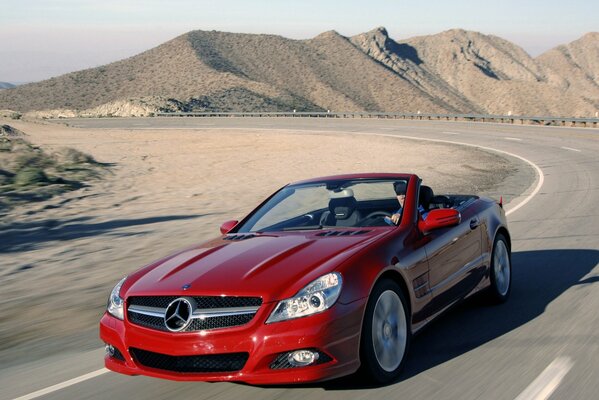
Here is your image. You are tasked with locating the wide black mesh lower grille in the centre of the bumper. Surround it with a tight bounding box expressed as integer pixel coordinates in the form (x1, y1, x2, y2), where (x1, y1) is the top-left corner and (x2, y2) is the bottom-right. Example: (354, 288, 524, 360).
(129, 347, 249, 373)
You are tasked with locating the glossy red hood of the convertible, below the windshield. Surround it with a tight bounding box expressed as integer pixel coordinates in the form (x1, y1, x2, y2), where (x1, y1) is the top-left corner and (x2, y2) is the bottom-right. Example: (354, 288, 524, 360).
(125, 229, 388, 302)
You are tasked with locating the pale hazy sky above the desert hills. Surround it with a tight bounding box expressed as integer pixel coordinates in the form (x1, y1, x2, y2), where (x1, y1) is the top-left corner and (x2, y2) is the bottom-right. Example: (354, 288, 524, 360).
(0, 0, 599, 83)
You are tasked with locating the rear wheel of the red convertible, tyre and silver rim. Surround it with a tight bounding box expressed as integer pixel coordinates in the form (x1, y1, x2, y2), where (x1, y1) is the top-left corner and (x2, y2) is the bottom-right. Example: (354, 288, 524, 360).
(486, 233, 512, 304)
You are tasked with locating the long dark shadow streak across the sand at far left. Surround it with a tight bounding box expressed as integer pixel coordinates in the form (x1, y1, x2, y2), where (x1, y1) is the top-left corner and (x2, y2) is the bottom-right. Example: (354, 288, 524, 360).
(0, 214, 210, 254)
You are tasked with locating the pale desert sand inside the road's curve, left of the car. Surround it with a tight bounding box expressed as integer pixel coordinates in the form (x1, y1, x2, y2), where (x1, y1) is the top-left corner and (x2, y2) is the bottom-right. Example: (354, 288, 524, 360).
(0, 120, 517, 365)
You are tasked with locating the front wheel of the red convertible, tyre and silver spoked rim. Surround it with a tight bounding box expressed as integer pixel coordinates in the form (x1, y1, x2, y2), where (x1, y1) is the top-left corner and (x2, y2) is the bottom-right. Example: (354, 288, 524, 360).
(360, 280, 412, 384)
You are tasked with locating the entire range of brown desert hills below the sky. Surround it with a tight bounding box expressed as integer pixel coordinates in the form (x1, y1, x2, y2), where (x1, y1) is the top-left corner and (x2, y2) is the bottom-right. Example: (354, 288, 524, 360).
(0, 28, 599, 116)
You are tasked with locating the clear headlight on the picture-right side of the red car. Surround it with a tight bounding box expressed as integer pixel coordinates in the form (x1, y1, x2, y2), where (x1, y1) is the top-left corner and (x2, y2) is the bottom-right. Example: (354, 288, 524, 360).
(266, 272, 341, 324)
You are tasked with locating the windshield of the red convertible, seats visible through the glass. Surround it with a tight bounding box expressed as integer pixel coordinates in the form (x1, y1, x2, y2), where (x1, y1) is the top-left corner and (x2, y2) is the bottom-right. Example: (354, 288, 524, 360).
(237, 179, 407, 232)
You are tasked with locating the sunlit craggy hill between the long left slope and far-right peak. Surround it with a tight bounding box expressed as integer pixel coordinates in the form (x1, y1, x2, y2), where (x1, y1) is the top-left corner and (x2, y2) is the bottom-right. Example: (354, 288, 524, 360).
(404, 30, 599, 116)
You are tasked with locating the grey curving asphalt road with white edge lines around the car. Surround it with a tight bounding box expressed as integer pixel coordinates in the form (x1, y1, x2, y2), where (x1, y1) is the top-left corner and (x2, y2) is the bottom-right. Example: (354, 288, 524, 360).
(0, 118, 599, 400)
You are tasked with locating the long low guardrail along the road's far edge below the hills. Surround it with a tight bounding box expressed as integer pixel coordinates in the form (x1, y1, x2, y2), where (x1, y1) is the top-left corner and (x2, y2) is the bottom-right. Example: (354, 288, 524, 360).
(155, 111, 599, 128)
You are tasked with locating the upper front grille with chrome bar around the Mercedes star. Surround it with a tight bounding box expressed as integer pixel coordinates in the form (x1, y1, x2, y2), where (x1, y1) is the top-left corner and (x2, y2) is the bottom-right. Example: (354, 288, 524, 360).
(127, 296, 262, 332)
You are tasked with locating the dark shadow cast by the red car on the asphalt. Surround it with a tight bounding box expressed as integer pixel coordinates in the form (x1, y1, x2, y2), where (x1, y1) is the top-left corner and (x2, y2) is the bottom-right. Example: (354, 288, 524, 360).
(258, 250, 599, 390)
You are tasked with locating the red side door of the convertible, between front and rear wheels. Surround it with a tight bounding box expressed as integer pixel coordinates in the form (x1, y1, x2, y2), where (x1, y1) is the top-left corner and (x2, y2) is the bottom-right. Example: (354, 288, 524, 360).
(425, 208, 484, 315)
